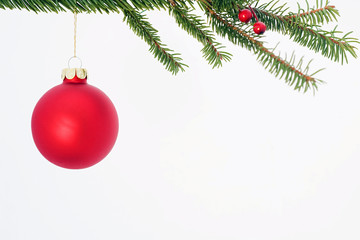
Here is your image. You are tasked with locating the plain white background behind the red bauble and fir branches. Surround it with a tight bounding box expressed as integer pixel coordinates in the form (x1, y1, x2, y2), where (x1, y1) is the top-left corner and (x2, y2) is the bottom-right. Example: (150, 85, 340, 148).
(0, 0, 360, 240)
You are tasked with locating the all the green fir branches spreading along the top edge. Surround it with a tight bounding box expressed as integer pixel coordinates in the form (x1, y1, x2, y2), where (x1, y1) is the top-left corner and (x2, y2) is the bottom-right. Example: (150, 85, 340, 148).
(0, 0, 359, 92)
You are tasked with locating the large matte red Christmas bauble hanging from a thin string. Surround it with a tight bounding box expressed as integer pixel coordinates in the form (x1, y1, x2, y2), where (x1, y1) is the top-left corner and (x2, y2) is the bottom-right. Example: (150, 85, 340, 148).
(31, 69, 119, 169)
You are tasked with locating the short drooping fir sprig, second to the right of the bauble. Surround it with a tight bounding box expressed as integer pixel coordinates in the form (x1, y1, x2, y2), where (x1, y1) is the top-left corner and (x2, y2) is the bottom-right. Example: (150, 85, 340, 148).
(169, 0, 232, 68)
